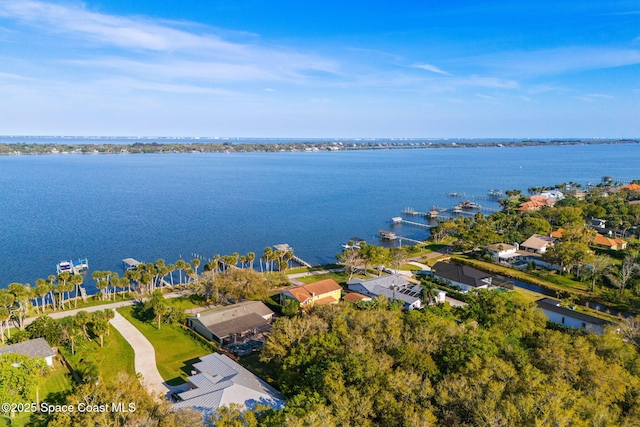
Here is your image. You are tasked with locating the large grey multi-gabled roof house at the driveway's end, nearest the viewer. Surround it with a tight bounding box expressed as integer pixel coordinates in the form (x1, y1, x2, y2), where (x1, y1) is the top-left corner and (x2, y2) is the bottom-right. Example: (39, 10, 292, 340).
(174, 353, 284, 415)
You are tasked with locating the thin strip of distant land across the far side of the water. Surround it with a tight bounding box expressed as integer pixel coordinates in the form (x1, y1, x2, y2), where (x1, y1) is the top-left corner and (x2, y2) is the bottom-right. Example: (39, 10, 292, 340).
(0, 137, 640, 155)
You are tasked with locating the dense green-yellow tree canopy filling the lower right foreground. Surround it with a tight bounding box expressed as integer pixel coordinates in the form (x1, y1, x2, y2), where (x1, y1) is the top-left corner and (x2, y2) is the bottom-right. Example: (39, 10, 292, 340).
(251, 291, 640, 426)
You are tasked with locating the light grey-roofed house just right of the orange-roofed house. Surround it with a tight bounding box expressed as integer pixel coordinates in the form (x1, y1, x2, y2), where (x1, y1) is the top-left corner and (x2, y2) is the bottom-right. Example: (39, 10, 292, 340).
(347, 274, 422, 310)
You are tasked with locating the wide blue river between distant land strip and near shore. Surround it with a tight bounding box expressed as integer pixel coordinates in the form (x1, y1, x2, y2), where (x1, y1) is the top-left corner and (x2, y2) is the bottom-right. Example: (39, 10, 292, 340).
(0, 144, 640, 290)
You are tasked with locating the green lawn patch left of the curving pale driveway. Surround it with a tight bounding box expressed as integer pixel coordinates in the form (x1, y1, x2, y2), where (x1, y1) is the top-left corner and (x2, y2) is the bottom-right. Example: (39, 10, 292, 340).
(61, 326, 136, 381)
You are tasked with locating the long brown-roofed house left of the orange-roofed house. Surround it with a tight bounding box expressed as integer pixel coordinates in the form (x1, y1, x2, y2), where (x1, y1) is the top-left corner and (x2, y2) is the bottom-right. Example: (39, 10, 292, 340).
(187, 301, 273, 345)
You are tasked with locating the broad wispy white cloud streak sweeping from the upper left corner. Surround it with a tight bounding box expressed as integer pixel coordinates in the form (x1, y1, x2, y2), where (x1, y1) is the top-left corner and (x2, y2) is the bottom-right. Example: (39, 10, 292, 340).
(0, 0, 338, 80)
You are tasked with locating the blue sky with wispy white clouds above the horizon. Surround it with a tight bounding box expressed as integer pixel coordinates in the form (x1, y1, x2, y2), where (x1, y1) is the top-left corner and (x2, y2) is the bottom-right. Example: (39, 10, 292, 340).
(0, 0, 640, 138)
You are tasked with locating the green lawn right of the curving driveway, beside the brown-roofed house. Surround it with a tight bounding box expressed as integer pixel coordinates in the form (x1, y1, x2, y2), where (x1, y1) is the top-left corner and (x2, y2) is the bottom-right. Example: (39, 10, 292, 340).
(118, 307, 212, 385)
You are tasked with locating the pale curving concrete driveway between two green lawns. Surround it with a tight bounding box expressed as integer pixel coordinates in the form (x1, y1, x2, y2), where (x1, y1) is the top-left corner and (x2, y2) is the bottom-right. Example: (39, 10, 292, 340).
(110, 311, 171, 397)
